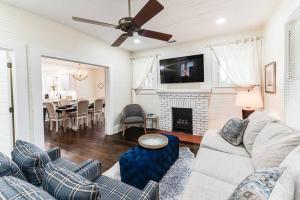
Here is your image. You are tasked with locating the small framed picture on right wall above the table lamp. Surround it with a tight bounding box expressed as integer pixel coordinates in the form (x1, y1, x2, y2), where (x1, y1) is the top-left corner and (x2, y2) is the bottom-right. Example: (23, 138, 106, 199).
(265, 62, 276, 94)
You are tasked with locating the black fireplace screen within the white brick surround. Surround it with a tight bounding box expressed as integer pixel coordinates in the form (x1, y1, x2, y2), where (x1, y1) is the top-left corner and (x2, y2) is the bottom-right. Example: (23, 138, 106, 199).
(172, 108, 193, 134)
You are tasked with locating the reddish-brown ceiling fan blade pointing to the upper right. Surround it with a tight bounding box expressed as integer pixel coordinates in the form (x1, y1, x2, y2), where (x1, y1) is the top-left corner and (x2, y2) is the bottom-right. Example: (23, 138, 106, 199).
(133, 0, 164, 27)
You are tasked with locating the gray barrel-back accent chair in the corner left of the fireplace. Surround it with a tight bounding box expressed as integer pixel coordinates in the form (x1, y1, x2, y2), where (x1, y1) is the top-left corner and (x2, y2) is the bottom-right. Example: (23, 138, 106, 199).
(121, 104, 147, 136)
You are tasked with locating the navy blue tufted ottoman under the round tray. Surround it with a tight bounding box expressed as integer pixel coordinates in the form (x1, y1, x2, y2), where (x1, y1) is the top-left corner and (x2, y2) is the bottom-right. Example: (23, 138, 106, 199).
(119, 135, 179, 189)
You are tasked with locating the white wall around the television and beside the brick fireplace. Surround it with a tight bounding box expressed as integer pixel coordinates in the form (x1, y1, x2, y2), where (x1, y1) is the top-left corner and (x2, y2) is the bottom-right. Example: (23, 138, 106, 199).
(132, 30, 261, 128)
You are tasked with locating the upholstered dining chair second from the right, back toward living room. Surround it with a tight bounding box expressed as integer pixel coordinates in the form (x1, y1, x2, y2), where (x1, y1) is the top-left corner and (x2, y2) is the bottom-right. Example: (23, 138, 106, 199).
(75, 100, 89, 129)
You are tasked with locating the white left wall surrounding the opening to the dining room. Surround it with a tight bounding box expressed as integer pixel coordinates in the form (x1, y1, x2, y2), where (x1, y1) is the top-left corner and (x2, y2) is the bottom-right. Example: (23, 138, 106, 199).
(0, 3, 131, 147)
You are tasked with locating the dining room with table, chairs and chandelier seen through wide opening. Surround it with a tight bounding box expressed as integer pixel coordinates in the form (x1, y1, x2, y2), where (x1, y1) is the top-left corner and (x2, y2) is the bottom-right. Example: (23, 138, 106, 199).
(42, 57, 106, 134)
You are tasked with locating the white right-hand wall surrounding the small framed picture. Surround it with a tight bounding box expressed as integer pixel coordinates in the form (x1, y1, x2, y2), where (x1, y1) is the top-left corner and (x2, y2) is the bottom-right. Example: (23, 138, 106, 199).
(263, 0, 300, 120)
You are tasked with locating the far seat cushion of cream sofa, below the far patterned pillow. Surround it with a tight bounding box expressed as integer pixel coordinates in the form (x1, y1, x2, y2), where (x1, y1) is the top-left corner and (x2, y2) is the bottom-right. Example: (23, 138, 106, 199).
(200, 129, 249, 157)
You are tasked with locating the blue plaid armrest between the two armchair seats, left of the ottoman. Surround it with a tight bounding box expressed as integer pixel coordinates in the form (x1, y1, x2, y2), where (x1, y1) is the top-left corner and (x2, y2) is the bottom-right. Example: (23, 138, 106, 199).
(76, 160, 101, 182)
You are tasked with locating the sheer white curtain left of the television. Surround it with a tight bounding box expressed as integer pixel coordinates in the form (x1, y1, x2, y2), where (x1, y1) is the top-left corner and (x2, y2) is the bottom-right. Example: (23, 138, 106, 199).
(132, 56, 157, 89)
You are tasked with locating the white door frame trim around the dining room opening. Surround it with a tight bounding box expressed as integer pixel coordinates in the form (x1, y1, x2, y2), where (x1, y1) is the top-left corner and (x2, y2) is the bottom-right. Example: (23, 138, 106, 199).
(27, 45, 113, 148)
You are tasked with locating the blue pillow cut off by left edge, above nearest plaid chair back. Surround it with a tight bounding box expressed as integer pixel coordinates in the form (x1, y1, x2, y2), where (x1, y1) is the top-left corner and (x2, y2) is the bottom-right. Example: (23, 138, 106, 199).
(0, 152, 26, 181)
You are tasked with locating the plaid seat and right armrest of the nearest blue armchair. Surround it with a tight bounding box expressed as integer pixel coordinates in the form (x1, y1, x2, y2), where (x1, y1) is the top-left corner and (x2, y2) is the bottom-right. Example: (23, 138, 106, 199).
(95, 176, 158, 200)
